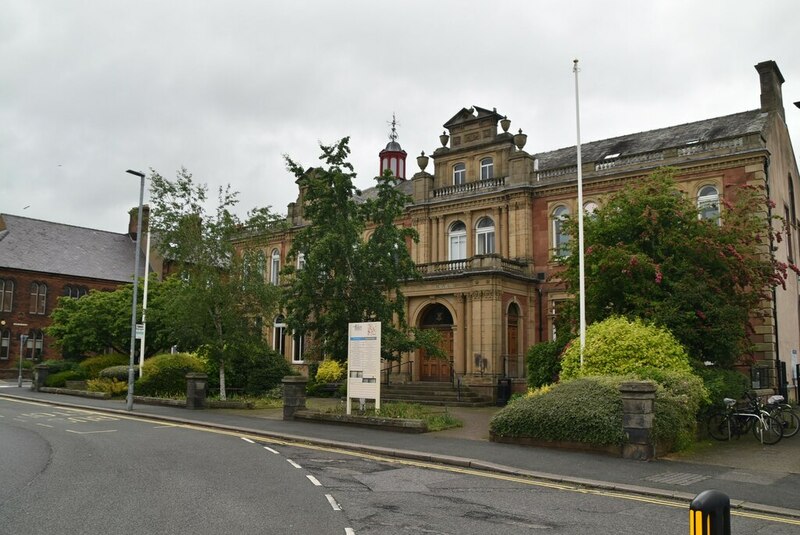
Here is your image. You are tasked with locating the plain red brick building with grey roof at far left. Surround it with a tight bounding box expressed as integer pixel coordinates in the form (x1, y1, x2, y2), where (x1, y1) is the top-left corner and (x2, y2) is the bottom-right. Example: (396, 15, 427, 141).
(0, 210, 152, 375)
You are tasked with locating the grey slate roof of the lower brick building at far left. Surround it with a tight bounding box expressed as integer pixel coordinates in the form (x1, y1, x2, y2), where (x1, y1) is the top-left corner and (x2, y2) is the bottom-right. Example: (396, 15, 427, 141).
(0, 214, 145, 282)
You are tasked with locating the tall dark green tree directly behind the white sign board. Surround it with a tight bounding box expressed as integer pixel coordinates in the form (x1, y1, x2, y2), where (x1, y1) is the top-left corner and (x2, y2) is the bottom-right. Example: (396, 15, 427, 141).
(282, 138, 441, 361)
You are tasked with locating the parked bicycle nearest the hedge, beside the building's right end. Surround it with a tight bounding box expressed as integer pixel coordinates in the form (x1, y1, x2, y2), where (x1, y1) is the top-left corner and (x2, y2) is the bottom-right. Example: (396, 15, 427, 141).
(707, 398, 783, 445)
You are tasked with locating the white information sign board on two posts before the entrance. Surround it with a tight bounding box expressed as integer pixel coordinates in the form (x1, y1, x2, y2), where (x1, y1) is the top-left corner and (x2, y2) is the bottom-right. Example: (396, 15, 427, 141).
(347, 321, 381, 414)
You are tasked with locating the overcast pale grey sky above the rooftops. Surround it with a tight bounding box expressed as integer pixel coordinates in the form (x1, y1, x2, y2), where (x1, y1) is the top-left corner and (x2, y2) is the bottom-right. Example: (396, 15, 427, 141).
(0, 0, 800, 232)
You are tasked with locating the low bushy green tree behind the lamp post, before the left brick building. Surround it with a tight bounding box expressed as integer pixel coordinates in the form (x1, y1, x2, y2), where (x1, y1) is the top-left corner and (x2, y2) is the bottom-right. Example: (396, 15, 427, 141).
(47, 277, 168, 358)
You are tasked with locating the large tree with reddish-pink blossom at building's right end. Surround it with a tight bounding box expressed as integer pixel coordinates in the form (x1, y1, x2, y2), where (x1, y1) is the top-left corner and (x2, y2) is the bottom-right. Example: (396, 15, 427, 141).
(561, 169, 794, 367)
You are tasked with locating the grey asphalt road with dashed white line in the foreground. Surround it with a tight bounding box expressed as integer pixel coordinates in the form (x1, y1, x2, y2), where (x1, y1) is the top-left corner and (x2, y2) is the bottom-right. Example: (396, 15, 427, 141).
(0, 399, 800, 535)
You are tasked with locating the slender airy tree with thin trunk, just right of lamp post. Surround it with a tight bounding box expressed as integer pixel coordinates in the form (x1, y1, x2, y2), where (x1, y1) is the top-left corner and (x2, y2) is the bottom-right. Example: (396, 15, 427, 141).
(148, 169, 278, 399)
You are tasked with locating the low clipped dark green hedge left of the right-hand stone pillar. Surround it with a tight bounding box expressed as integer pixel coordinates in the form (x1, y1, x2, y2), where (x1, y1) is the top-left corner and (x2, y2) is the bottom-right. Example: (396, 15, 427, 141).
(490, 377, 625, 446)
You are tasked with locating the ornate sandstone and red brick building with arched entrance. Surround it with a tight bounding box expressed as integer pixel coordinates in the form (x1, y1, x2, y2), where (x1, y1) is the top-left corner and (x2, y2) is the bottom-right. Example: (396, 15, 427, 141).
(256, 61, 800, 402)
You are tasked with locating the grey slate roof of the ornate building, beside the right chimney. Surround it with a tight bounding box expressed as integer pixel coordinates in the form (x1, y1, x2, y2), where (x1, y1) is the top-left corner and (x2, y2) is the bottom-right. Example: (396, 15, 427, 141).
(534, 110, 768, 170)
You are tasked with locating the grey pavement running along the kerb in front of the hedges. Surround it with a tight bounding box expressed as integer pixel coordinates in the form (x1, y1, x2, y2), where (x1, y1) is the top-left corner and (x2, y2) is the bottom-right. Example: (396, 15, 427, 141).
(0, 380, 800, 519)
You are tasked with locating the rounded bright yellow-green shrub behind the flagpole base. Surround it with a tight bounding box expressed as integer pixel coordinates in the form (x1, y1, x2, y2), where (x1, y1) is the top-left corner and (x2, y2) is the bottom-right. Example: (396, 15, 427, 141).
(561, 316, 691, 379)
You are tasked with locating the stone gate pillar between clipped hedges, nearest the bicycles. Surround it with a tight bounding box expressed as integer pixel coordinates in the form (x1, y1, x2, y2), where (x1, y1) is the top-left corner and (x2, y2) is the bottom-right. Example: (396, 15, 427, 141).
(619, 381, 656, 461)
